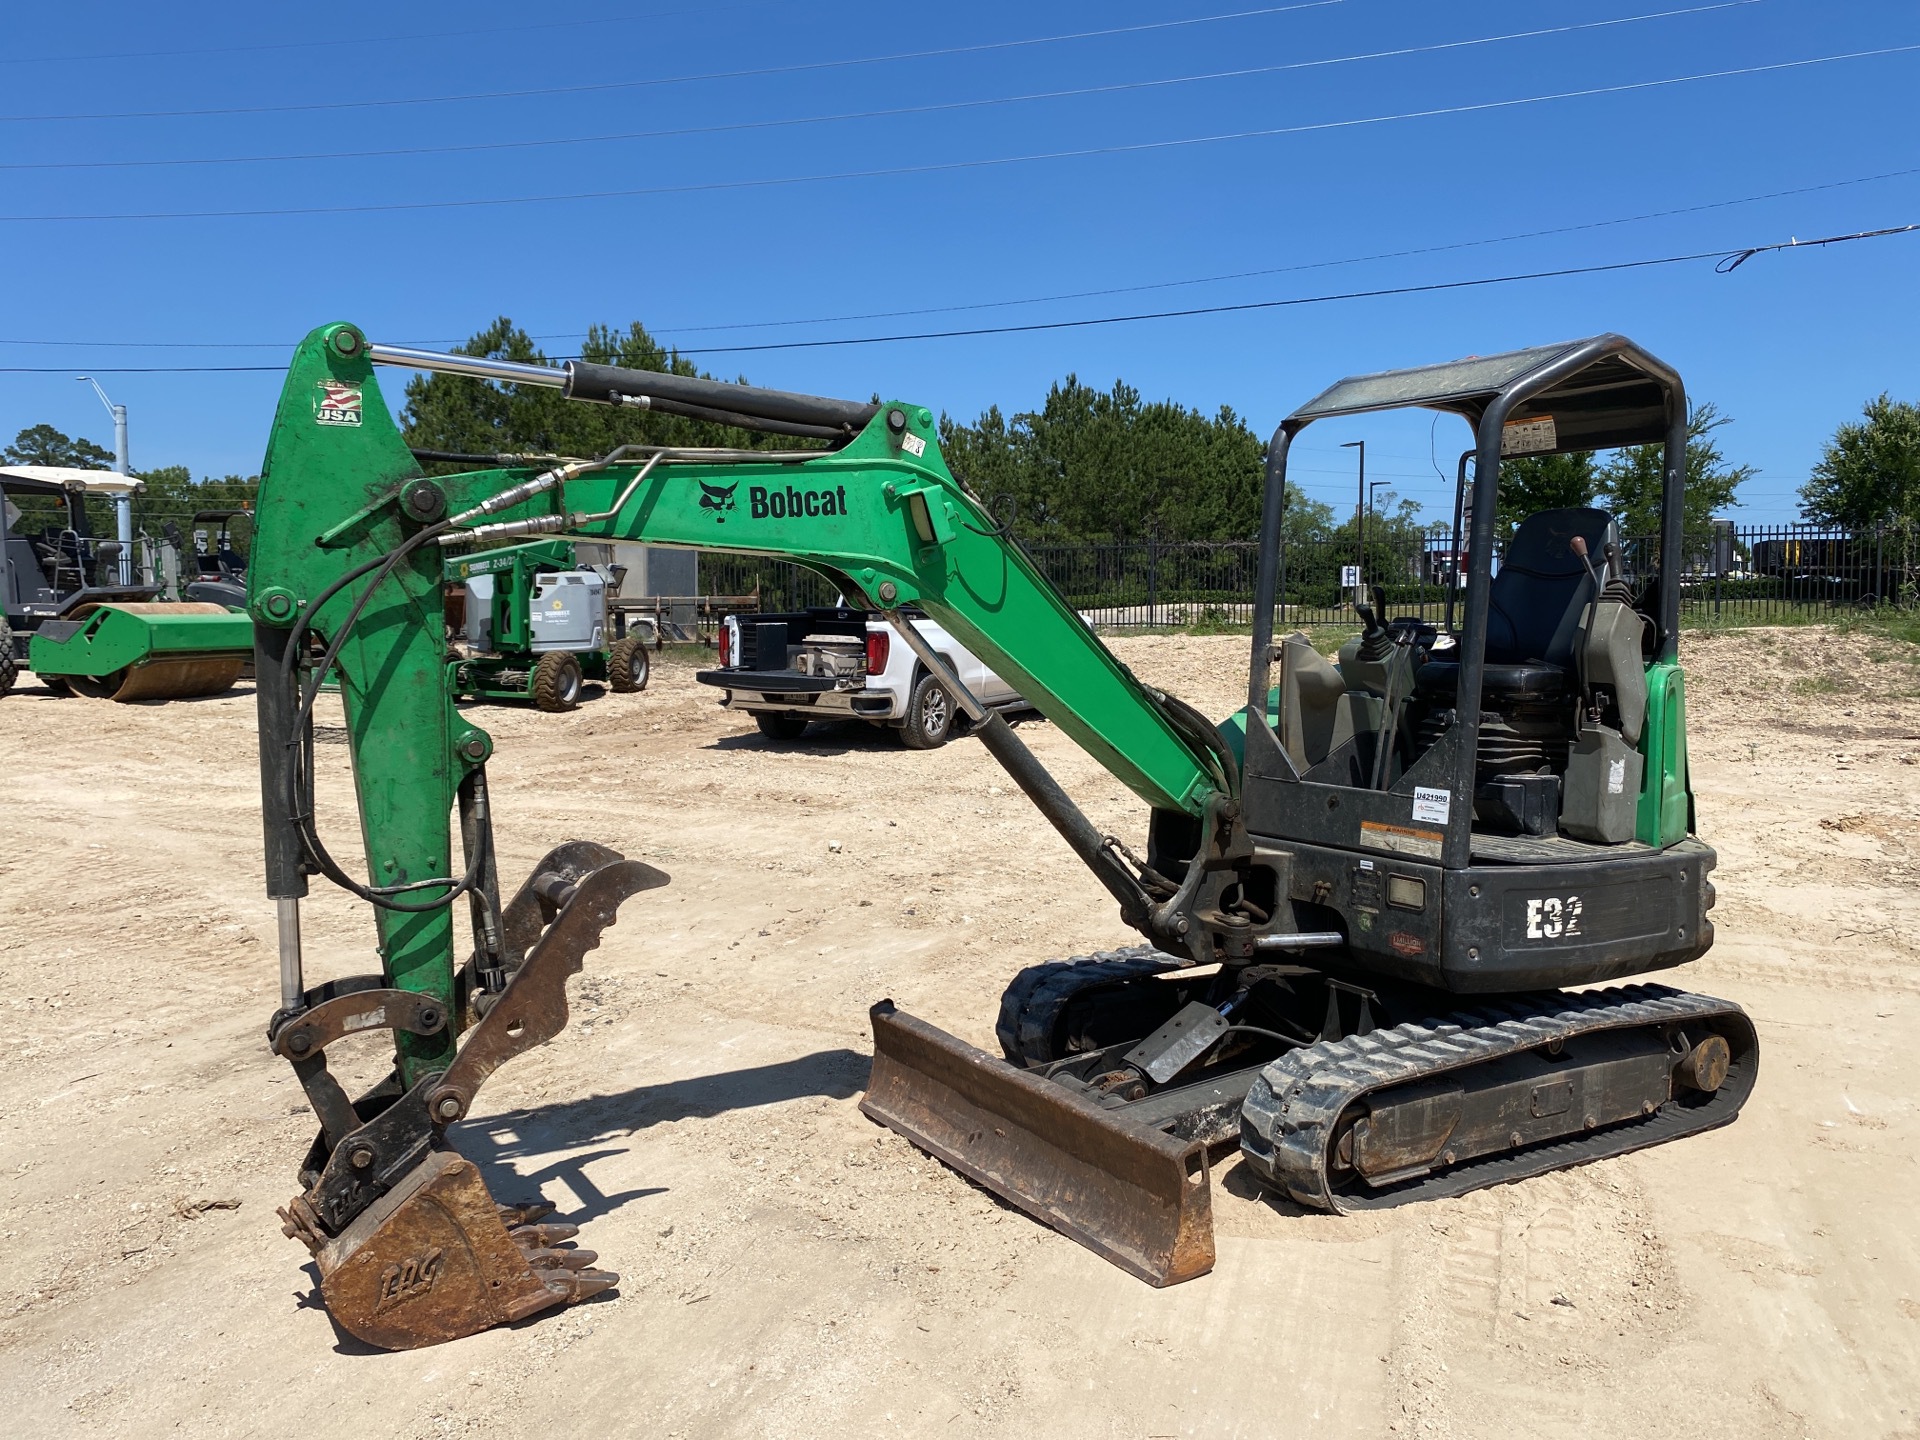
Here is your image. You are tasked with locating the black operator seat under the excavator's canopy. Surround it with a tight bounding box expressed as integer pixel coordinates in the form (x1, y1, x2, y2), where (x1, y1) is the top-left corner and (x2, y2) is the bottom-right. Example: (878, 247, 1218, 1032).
(1413, 507, 1619, 705)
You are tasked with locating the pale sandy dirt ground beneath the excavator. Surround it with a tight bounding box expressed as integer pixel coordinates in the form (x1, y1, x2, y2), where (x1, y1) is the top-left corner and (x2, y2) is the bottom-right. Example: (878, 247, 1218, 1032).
(0, 630, 1920, 1440)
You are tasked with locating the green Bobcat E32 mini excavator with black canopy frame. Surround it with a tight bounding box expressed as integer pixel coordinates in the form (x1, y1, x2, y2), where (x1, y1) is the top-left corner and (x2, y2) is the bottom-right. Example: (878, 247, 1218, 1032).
(248, 324, 1757, 1348)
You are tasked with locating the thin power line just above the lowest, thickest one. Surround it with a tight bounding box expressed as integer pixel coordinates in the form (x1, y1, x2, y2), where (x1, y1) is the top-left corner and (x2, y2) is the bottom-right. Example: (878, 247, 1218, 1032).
(0, 167, 1920, 351)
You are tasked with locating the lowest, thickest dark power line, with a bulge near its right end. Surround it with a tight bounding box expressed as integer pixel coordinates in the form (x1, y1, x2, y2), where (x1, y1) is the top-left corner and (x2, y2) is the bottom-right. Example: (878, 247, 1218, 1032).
(0, 223, 1920, 374)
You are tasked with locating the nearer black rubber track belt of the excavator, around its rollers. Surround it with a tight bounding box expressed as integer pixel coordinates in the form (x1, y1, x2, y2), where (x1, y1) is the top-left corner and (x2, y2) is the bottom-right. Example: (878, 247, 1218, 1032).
(1240, 985, 1759, 1213)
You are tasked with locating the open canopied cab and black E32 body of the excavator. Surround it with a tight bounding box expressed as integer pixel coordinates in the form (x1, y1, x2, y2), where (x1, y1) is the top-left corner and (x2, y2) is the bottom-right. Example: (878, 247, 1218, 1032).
(1213, 334, 1715, 993)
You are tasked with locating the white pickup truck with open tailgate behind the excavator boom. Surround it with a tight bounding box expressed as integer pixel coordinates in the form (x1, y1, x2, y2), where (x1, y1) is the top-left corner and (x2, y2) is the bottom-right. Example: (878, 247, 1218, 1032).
(697, 607, 1025, 751)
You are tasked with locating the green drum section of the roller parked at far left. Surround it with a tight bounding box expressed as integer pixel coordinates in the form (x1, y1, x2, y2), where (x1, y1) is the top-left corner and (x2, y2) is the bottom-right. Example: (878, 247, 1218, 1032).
(27, 601, 253, 701)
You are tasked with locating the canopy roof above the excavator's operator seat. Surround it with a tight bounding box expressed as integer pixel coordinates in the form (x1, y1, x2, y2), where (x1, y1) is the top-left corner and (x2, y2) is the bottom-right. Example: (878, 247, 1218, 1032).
(1286, 334, 1684, 453)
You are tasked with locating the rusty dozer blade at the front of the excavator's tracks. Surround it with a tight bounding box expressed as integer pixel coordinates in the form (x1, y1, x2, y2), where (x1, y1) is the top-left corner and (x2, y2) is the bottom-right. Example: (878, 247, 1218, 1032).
(860, 1000, 1213, 1284)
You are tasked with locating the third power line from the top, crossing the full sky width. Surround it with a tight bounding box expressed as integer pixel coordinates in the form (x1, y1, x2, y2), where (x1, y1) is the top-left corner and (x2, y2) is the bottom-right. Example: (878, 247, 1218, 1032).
(11, 44, 1920, 225)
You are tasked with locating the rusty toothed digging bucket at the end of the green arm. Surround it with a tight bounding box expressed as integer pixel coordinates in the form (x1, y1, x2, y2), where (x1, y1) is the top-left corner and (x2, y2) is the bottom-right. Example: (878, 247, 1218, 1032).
(288, 1150, 618, 1350)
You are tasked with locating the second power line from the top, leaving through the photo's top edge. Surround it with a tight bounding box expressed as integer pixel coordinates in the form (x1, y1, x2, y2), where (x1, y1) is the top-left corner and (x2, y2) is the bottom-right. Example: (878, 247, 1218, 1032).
(0, 0, 1761, 171)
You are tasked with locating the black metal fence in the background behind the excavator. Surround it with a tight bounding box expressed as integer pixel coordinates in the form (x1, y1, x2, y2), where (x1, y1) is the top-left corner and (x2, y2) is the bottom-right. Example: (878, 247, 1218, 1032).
(701, 524, 1920, 630)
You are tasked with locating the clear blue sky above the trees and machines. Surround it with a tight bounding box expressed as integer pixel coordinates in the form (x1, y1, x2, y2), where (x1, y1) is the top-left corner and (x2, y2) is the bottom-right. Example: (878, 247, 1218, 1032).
(0, 0, 1920, 522)
